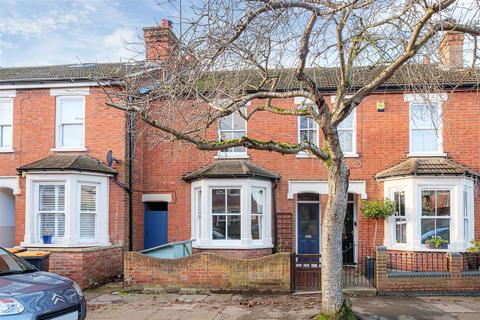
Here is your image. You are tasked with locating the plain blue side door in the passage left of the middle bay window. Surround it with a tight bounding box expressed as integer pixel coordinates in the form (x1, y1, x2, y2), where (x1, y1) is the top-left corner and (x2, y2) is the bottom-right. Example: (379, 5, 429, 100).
(144, 204, 168, 249)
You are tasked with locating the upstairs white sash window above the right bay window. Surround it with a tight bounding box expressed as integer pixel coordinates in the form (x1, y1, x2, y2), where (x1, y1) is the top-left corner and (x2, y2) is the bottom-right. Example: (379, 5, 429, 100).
(410, 102, 443, 155)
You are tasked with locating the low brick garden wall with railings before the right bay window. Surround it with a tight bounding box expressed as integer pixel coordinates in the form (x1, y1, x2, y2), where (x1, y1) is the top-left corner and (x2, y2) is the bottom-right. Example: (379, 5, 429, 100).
(375, 247, 480, 294)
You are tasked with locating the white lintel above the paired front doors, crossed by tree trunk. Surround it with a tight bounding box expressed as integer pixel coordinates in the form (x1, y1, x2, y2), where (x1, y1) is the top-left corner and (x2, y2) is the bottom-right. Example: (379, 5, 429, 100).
(287, 180, 367, 199)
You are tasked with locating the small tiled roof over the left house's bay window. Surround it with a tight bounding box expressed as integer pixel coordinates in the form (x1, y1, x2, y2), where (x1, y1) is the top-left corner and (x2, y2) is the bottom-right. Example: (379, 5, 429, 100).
(17, 154, 118, 174)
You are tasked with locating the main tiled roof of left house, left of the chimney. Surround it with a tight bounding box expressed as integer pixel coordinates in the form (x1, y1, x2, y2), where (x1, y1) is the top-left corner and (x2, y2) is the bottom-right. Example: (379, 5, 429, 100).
(0, 63, 146, 83)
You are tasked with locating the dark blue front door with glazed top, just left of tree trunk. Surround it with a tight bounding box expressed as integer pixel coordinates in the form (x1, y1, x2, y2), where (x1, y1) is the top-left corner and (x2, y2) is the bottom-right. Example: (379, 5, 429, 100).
(297, 202, 320, 254)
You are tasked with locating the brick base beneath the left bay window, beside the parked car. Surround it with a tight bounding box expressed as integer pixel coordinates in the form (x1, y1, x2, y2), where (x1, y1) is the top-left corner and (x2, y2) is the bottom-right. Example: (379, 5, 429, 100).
(39, 245, 123, 288)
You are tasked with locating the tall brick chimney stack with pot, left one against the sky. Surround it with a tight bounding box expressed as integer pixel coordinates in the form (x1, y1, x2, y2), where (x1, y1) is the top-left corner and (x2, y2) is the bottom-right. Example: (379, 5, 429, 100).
(143, 19, 178, 62)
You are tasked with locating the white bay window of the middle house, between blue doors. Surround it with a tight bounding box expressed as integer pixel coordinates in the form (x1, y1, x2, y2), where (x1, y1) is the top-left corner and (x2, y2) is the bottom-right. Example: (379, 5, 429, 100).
(192, 178, 273, 249)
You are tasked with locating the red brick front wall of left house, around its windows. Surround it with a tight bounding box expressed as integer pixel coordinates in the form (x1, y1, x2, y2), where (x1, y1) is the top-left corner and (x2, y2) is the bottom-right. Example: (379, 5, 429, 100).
(0, 88, 127, 248)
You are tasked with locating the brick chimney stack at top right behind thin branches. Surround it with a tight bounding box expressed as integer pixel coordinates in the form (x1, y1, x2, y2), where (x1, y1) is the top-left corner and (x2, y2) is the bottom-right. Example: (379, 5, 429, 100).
(439, 31, 465, 69)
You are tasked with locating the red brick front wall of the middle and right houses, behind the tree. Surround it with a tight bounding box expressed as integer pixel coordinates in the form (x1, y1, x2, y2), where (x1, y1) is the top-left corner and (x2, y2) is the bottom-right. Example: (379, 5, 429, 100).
(137, 92, 480, 252)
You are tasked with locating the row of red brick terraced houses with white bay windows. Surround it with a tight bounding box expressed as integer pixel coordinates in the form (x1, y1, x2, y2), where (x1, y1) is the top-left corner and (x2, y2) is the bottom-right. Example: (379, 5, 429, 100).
(0, 21, 480, 286)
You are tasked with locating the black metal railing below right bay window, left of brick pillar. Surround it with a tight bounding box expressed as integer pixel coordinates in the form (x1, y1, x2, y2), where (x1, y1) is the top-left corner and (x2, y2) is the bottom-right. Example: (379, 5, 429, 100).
(387, 251, 449, 272)
